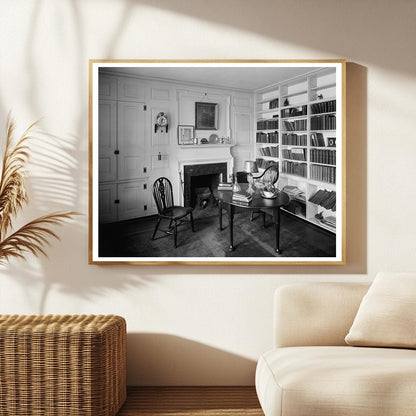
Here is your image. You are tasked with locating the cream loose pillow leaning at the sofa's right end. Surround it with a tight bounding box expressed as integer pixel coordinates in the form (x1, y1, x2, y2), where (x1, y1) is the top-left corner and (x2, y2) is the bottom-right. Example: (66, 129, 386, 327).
(345, 273, 416, 348)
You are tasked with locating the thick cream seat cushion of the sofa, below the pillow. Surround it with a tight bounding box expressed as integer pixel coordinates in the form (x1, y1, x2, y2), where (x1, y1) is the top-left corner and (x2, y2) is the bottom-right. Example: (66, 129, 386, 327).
(256, 346, 416, 416)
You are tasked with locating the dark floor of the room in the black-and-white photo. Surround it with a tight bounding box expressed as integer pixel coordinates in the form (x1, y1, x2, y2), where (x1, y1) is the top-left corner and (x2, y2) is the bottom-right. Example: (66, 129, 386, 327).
(99, 203, 336, 258)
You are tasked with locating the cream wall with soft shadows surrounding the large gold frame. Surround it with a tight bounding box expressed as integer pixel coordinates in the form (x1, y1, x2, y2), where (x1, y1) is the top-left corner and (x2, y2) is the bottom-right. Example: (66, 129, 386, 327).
(0, 0, 416, 385)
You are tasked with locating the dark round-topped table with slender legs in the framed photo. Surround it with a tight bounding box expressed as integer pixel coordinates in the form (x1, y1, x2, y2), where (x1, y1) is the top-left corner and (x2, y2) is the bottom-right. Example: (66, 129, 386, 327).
(218, 185, 289, 254)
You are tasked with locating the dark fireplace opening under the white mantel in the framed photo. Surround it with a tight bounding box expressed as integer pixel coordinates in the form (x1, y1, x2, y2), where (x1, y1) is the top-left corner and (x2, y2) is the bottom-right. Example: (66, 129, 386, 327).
(183, 162, 227, 207)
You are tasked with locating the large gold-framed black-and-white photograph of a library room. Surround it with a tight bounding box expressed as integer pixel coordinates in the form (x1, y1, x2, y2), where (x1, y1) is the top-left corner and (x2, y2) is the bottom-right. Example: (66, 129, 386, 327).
(89, 59, 346, 266)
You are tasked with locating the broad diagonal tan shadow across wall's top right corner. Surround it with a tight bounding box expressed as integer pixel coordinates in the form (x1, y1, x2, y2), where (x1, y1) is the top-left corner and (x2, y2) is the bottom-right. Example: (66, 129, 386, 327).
(132, 0, 416, 74)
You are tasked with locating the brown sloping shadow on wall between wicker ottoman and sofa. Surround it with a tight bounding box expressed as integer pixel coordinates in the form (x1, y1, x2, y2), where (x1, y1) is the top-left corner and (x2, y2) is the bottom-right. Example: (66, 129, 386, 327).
(127, 333, 256, 386)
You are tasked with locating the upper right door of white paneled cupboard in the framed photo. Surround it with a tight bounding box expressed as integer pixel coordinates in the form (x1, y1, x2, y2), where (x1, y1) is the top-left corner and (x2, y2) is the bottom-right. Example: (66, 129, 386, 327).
(117, 101, 149, 181)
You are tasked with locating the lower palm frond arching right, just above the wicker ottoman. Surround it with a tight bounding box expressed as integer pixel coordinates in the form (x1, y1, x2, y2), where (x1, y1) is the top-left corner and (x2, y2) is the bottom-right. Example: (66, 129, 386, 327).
(0, 211, 77, 263)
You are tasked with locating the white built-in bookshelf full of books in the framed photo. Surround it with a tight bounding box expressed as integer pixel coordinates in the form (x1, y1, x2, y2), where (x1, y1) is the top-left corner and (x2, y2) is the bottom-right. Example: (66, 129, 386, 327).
(255, 68, 337, 232)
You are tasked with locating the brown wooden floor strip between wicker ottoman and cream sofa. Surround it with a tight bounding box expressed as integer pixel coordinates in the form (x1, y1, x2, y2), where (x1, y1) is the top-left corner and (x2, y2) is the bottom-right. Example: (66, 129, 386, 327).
(117, 386, 264, 416)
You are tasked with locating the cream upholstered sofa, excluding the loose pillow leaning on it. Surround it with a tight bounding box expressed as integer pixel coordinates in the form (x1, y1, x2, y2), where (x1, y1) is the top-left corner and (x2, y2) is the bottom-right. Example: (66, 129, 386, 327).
(256, 283, 416, 416)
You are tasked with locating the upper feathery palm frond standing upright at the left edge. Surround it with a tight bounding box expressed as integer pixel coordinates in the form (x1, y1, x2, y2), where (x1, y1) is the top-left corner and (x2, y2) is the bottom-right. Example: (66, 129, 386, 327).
(0, 116, 37, 237)
